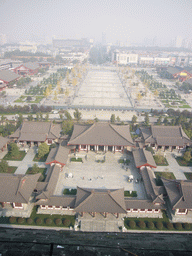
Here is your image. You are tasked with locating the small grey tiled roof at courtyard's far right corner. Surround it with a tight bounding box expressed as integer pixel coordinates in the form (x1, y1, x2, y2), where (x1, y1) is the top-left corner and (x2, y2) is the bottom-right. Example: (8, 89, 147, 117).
(133, 148, 157, 168)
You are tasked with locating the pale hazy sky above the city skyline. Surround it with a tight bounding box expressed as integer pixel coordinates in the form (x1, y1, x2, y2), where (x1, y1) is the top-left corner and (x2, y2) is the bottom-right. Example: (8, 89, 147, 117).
(0, 0, 192, 44)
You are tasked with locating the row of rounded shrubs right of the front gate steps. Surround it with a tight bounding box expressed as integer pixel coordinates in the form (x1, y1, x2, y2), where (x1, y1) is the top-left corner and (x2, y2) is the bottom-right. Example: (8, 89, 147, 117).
(127, 220, 192, 231)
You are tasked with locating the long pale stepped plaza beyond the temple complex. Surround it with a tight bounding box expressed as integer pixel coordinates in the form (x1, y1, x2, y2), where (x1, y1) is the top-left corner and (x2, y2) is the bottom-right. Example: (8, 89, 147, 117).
(72, 69, 131, 107)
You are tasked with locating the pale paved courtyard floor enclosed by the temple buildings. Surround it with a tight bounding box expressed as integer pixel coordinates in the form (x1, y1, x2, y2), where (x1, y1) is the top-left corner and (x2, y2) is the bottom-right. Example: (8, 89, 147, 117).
(55, 152, 146, 199)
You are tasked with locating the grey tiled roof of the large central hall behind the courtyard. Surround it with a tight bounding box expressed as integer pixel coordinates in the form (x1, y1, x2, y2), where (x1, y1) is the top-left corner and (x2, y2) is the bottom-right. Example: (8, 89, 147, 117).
(68, 123, 135, 146)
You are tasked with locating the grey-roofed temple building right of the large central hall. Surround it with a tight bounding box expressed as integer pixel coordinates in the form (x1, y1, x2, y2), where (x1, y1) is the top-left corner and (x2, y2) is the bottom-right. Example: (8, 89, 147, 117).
(137, 125, 192, 151)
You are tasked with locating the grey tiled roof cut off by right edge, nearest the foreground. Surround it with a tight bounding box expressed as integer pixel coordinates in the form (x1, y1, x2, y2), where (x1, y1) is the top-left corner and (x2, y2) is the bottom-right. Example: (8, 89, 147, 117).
(162, 178, 192, 209)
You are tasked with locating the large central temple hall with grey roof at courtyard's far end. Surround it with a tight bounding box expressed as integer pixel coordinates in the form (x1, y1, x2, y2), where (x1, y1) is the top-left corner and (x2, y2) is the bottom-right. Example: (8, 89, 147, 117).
(68, 123, 135, 152)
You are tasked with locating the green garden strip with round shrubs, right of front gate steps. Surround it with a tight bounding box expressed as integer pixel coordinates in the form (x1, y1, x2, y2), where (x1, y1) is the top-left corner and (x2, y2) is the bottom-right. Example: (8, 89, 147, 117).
(124, 212, 192, 231)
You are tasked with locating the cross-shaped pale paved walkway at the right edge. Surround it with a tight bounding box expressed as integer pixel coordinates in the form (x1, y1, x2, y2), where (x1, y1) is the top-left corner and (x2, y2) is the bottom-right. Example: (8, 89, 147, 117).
(155, 152, 192, 180)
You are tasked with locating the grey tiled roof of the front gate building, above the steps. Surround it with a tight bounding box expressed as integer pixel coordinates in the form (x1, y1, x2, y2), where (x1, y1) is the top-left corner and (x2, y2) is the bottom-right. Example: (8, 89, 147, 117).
(75, 187, 126, 213)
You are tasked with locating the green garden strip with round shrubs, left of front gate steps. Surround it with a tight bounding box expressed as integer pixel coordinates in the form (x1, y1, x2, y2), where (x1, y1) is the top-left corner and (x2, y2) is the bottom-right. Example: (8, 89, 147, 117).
(0, 207, 75, 228)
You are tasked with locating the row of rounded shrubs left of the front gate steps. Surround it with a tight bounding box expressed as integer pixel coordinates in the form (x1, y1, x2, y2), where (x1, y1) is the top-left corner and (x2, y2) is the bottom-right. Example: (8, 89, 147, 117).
(9, 217, 71, 227)
